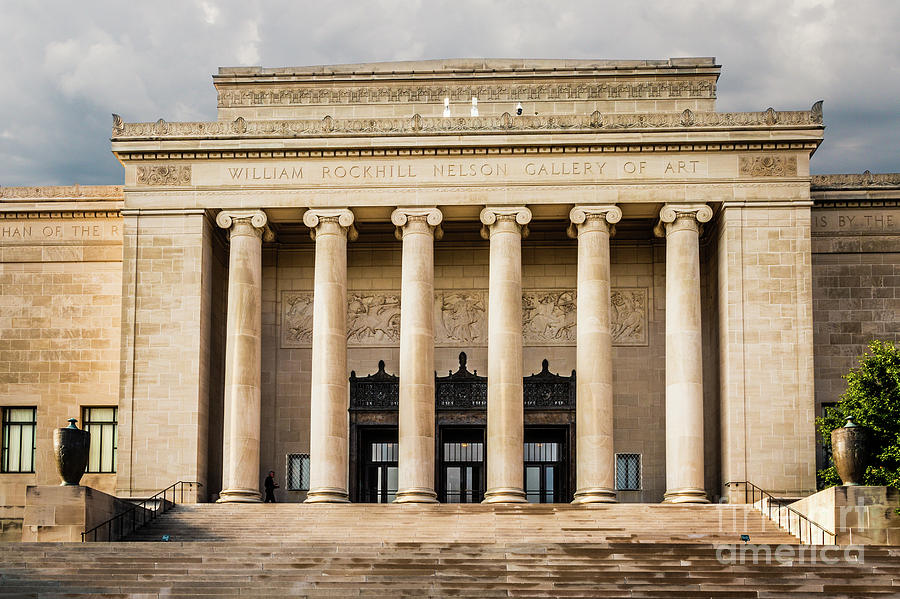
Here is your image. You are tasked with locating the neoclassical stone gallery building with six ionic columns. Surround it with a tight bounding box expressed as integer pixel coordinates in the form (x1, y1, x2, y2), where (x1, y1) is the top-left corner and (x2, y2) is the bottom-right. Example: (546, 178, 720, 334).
(0, 58, 900, 536)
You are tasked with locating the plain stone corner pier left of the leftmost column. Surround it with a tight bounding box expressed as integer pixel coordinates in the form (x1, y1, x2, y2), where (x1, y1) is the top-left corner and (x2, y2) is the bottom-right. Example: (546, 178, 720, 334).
(117, 210, 224, 498)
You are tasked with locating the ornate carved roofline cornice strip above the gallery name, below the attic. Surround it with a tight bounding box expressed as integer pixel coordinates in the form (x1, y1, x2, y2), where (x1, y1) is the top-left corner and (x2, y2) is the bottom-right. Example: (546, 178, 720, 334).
(112, 102, 822, 142)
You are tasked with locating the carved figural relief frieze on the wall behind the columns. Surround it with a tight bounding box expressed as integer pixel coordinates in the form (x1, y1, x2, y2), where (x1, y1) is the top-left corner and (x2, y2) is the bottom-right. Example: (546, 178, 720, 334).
(281, 287, 649, 348)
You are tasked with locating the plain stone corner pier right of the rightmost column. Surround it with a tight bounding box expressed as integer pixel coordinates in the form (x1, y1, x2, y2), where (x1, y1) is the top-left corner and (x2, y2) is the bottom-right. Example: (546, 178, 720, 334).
(717, 204, 815, 494)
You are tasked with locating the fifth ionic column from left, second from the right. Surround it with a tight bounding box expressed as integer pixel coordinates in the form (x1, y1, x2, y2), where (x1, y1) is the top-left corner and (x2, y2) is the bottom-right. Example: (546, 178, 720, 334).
(569, 206, 622, 503)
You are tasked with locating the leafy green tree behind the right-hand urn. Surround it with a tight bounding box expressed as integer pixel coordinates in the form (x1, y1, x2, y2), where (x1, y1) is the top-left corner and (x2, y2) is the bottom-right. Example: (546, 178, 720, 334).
(816, 341, 900, 488)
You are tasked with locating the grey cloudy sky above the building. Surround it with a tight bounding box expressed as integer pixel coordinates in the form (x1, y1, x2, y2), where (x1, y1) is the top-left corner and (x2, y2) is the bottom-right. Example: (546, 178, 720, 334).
(0, 0, 900, 186)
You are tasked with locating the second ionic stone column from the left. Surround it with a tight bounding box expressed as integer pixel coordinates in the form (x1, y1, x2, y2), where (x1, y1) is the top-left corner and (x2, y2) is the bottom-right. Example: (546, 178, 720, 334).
(303, 209, 356, 503)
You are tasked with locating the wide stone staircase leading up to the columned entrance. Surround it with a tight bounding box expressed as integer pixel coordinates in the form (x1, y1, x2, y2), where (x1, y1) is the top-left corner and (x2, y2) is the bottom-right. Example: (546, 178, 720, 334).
(0, 504, 900, 599)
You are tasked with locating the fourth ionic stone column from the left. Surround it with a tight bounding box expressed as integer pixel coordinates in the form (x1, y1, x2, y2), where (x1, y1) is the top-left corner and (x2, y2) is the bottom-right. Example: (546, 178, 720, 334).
(481, 206, 531, 503)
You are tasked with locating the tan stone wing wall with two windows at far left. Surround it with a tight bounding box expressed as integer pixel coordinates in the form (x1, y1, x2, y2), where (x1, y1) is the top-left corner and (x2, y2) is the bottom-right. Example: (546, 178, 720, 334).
(0, 186, 122, 534)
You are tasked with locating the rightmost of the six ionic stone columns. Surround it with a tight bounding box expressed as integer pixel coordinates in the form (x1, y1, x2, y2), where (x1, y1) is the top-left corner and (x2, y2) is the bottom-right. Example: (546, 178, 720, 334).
(655, 204, 712, 503)
